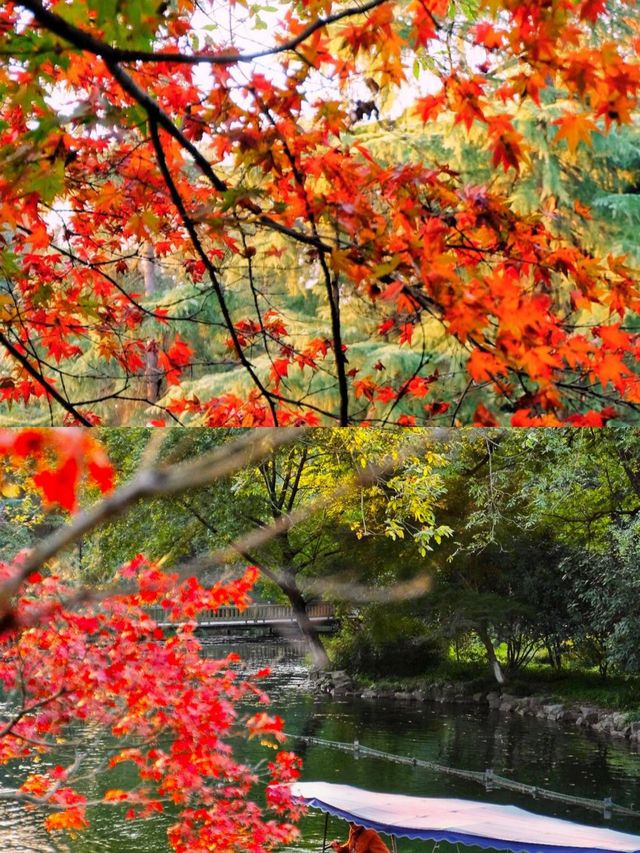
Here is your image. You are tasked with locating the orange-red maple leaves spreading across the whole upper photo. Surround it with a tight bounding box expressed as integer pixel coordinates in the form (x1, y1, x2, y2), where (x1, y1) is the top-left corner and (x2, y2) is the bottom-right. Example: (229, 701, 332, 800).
(0, 0, 640, 426)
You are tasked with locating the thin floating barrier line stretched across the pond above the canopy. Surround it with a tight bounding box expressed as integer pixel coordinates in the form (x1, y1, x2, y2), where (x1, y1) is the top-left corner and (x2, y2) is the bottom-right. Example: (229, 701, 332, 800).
(285, 732, 640, 819)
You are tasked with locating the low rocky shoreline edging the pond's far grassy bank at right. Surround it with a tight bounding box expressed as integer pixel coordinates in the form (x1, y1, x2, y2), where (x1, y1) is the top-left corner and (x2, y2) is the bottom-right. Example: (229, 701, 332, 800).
(312, 670, 640, 747)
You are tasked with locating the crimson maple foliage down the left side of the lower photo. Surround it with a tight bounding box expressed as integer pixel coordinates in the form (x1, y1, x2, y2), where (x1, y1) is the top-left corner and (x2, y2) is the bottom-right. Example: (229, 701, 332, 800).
(0, 430, 298, 853)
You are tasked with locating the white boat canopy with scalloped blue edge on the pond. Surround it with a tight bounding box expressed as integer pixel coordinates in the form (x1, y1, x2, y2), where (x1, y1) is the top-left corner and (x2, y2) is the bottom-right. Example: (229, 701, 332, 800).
(291, 782, 640, 853)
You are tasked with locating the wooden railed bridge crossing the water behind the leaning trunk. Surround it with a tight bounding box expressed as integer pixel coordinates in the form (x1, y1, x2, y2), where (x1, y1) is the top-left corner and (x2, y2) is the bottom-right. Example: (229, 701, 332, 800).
(147, 603, 337, 633)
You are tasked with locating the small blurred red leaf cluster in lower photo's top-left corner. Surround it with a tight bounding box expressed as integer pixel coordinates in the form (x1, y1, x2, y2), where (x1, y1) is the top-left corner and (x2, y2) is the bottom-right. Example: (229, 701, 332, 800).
(0, 428, 115, 512)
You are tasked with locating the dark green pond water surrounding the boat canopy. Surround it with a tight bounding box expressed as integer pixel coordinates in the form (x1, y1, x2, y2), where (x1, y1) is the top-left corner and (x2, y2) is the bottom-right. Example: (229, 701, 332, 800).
(0, 640, 640, 853)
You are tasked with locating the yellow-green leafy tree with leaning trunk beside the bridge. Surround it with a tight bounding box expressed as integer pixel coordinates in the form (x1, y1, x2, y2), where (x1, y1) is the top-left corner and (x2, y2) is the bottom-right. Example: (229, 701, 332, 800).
(85, 429, 451, 667)
